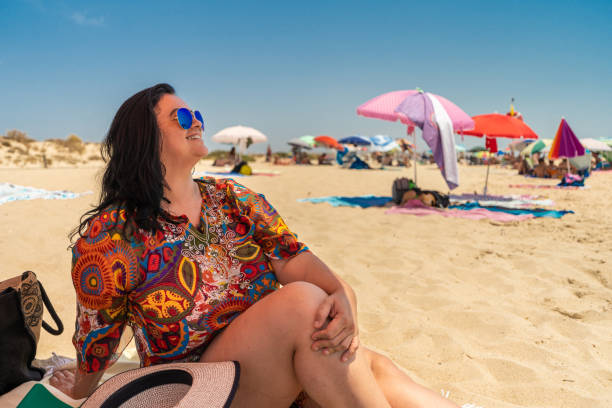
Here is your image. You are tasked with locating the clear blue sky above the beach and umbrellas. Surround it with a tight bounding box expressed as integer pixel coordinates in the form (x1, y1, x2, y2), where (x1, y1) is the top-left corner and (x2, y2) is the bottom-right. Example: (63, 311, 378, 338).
(0, 0, 612, 151)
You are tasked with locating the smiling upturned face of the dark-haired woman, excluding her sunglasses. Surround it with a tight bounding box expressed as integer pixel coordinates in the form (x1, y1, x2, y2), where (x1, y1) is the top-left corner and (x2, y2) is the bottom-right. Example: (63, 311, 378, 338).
(155, 94, 208, 169)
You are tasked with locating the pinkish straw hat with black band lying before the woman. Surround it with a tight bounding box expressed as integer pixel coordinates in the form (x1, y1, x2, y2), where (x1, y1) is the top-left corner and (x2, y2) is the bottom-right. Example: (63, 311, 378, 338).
(81, 361, 240, 408)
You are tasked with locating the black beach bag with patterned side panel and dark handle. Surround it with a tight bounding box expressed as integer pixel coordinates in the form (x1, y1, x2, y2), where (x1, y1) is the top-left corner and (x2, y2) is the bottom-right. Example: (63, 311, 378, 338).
(0, 271, 64, 395)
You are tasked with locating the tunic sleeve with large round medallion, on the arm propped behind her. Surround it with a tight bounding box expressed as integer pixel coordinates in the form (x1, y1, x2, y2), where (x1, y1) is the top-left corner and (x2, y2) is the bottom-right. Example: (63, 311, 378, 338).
(72, 219, 138, 373)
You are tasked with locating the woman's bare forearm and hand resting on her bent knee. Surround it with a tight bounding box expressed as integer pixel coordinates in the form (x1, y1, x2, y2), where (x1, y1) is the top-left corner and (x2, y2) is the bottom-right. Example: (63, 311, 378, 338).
(271, 251, 359, 361)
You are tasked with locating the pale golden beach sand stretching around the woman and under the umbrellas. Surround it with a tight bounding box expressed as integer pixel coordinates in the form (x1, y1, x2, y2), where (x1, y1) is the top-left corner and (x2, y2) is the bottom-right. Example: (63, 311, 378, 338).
(0, 161, 612, 408)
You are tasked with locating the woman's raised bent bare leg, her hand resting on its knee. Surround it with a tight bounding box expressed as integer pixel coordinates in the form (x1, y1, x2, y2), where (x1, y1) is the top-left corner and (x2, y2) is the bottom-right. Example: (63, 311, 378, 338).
(201, 282, 389, 408)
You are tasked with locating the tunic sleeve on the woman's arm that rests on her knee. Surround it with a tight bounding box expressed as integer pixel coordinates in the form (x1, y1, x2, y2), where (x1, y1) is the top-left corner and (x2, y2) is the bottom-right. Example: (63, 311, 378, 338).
(227, 182, 308, 259)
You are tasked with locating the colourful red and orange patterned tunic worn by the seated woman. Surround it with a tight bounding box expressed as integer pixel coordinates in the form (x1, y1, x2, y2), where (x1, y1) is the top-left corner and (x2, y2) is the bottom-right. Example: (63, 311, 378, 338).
(72, 178, 308, 373)
